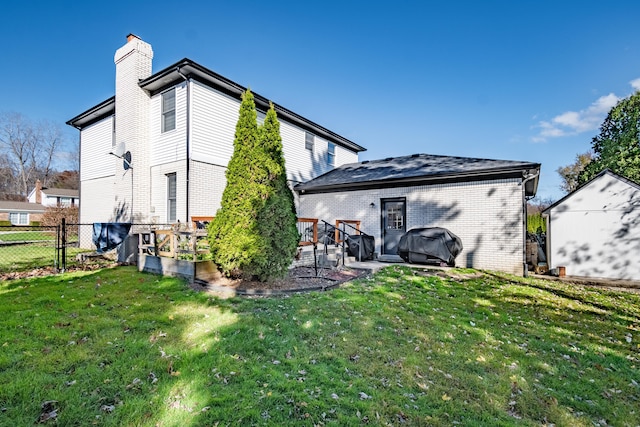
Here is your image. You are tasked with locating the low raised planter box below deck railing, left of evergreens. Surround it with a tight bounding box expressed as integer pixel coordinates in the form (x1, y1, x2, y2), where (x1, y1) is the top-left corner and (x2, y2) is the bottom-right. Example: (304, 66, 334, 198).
(138, 254, 221, 282)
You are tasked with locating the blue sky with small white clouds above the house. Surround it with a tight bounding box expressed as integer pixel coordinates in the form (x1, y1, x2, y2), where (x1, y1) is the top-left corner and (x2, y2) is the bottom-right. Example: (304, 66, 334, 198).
(0, 0, 640, 199)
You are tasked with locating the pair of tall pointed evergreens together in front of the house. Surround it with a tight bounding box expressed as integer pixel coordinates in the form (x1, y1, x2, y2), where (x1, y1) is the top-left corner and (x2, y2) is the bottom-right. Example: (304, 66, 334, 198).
(209, 90, 300, 281)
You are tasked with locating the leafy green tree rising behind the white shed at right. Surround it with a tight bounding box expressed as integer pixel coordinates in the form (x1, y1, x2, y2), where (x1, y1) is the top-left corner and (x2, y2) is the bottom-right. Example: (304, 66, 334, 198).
(578, 92, 640, 184)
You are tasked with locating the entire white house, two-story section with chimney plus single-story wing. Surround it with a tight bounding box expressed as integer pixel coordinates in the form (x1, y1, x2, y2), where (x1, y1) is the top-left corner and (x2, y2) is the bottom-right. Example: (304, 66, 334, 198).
(67, 35, 540, 274)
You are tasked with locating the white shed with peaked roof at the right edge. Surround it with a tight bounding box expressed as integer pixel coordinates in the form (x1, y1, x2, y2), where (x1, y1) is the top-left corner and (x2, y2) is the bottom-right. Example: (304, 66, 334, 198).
(542, 169, 640, 280)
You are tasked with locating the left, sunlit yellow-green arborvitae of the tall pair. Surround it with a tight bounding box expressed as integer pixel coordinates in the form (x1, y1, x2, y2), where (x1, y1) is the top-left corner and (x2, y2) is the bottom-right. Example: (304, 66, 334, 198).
(209, 90, 268, 277)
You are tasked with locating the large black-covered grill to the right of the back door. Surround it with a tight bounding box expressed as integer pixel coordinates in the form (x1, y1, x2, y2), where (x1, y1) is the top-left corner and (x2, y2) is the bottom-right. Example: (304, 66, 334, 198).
(398, 227, 462, 266)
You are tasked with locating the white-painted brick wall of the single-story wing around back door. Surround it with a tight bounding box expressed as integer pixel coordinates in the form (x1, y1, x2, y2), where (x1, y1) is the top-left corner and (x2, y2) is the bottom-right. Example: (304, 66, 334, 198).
(298, 179, 524, 275)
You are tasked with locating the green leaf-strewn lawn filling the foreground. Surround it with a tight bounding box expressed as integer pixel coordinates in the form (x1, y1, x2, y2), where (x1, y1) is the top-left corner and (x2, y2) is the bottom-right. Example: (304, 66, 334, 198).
(0, 267, 640, 426)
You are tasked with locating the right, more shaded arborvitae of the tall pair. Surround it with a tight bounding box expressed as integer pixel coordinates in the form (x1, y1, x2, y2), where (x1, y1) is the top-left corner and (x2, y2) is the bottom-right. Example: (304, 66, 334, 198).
(255, 104, 300, 280)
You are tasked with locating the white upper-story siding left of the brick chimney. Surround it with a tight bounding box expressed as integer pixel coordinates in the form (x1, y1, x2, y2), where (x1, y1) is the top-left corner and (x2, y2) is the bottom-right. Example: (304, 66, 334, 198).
(80, 117, 114, 181)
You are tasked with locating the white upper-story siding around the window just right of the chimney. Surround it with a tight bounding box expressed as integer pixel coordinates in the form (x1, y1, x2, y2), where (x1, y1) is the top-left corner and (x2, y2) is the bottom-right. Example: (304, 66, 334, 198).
(149, 83, 187, 167)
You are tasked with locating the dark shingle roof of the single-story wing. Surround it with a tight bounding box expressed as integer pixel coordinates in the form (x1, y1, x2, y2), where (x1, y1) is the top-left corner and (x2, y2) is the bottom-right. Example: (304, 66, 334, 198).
(295, 154, 540, 195)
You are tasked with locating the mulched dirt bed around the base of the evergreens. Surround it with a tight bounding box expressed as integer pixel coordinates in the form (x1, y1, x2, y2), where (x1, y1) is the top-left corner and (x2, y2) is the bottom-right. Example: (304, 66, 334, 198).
(193, 267, 368, 295)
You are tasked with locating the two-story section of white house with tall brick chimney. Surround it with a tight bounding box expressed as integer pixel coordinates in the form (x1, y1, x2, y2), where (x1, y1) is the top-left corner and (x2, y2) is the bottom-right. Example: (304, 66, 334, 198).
(67, 35, 364, 234)
